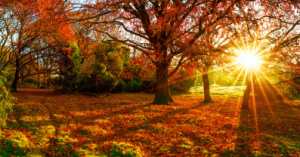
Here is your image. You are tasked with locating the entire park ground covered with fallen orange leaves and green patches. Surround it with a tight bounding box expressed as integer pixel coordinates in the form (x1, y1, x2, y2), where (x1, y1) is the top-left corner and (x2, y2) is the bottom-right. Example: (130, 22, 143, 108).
(0, 89, 300, 156)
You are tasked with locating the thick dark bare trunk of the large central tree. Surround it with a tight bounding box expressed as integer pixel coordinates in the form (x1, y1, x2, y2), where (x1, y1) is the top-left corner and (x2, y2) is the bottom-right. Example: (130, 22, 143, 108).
(153, 64, 173, 105)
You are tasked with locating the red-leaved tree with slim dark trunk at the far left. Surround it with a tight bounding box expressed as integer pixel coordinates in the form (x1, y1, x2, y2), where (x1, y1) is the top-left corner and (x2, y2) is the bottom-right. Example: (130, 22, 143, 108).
(0, 0, 72, 90)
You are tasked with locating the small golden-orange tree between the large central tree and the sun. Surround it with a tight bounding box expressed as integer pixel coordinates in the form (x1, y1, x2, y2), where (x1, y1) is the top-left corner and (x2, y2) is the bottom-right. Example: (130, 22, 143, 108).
(190, 25, 232, 103)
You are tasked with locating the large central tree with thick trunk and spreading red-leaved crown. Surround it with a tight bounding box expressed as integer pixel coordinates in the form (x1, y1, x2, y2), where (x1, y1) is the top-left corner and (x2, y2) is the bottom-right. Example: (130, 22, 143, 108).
(74, 0, 235, 104)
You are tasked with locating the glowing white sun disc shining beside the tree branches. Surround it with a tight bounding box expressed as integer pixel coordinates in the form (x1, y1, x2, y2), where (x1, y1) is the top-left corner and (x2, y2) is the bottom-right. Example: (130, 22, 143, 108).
(235, 51, 263, 69)
